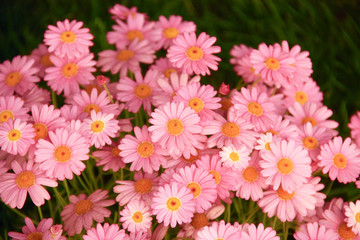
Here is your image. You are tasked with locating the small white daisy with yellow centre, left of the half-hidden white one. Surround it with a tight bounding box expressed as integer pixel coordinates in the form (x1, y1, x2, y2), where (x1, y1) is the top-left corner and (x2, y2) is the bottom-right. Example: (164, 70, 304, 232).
(219, 144, 251, 170)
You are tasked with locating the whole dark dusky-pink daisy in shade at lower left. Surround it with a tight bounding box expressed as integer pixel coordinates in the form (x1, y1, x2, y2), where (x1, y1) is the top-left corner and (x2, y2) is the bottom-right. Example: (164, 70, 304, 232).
(61, 189, 115, 237)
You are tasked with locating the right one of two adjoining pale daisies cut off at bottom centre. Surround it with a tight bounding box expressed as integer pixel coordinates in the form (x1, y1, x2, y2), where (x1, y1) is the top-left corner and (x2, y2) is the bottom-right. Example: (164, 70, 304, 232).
(241, 223, 280, 240)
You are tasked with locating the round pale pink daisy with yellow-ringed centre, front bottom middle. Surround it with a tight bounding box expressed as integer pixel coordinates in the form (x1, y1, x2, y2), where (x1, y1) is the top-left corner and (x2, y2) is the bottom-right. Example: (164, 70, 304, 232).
(151, 182, 195, 228)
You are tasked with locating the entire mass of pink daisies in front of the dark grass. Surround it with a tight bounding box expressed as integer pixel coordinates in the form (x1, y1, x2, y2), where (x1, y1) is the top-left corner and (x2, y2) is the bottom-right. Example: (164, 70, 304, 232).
(0, 4, 360, 240)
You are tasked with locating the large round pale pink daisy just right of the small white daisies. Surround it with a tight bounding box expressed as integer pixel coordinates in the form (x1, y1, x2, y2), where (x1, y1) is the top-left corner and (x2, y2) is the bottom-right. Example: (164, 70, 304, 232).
(259, 140, 311, 192)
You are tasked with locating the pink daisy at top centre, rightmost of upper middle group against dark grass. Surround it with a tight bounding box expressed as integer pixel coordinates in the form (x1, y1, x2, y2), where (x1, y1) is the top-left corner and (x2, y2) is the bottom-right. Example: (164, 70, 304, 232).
(166, 32, 221, 76)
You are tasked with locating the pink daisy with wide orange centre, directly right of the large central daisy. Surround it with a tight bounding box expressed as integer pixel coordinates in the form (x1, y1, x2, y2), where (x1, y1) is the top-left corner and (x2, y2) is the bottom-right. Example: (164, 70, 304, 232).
(201, 111, 258, 149)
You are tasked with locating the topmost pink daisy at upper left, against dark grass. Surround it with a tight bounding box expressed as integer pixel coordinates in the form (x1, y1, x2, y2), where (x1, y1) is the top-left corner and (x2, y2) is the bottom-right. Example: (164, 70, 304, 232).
(44, 19, 94, 58)
